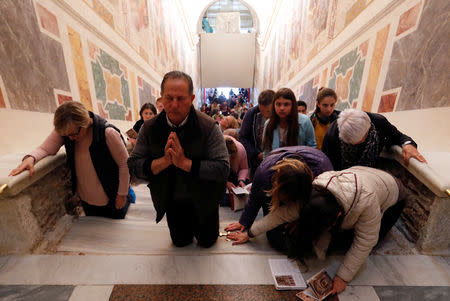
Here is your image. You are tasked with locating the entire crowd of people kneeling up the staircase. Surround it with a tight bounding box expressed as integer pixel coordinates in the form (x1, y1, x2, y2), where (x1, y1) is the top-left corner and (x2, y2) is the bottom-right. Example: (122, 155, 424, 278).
(10, 71, 426, 293)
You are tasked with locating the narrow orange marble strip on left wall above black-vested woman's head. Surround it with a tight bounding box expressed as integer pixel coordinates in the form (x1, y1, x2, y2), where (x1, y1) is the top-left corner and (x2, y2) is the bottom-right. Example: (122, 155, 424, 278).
(67, 26, 93, 111)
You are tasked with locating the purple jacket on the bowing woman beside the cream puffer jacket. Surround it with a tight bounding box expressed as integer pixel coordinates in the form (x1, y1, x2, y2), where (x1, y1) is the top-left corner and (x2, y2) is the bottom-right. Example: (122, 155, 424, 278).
(239, 146, 333, 228)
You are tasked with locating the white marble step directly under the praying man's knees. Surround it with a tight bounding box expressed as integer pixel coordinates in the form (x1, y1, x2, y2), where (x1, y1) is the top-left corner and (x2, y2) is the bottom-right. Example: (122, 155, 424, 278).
(57, 213, 278, 255)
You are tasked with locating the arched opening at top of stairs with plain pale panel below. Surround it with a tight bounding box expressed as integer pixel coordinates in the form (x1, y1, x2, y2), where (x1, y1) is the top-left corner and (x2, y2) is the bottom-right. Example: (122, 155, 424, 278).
(197, 0, 258, 95)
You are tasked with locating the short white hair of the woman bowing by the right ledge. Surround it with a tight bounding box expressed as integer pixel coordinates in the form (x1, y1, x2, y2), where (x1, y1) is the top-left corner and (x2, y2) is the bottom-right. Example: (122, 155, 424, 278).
(337, 109, 371, 144)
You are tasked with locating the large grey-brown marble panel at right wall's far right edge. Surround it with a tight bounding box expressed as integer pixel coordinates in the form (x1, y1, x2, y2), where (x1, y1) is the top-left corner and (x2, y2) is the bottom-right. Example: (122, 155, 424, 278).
(384, 0, 450, 111)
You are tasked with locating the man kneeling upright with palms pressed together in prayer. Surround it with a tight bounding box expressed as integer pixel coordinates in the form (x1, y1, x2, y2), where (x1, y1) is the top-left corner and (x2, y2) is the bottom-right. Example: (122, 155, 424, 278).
(128, 71, 230, 247)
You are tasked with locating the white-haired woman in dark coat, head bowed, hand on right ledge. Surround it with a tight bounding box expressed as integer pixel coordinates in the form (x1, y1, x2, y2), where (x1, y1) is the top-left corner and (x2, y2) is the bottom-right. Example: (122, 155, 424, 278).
(322, 109, 426, 170)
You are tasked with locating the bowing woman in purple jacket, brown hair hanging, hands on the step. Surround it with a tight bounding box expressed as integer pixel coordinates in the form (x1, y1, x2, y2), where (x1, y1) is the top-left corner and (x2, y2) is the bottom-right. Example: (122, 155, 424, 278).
(225, 146, 333, 252)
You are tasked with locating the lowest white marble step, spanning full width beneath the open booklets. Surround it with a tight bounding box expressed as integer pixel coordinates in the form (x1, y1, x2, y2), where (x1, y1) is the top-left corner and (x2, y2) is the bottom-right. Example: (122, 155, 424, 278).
(0, 254, 450, 286)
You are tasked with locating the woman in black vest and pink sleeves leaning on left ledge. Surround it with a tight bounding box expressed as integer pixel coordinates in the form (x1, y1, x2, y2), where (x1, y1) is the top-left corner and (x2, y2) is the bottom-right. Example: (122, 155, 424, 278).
(10, 101, 133, 219)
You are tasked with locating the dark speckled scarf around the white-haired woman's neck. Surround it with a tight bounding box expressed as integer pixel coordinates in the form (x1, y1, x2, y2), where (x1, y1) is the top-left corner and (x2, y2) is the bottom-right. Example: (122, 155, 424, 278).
(341, 123, 380, 169)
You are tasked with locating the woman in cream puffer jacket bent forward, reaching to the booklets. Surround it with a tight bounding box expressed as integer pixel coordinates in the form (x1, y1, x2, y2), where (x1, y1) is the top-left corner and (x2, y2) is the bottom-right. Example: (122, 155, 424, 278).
(289, 166, 405, 293)
